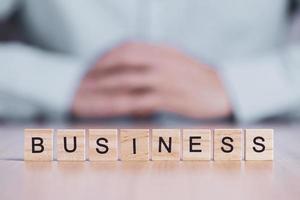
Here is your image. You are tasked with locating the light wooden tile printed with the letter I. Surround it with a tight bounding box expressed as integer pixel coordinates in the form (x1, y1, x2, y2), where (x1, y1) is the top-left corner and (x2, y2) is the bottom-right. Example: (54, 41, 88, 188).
(120, 129, 149, 160)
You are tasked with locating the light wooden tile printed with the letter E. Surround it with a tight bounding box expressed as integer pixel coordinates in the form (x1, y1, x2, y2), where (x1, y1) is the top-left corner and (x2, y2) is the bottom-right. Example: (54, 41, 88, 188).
(182, 129, 211, 160)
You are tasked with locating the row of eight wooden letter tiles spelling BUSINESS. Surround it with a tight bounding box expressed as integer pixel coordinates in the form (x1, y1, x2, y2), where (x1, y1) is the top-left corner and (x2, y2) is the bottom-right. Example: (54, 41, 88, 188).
(24, 129, 273, 161)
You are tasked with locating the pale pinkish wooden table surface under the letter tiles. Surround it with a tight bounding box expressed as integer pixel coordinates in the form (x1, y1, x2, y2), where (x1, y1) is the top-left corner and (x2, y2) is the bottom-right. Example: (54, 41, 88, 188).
(0, 124, 300, 200)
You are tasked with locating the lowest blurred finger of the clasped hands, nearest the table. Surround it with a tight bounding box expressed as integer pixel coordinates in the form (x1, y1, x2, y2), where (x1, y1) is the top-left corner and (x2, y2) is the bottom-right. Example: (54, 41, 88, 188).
(74, 94, 160, 117)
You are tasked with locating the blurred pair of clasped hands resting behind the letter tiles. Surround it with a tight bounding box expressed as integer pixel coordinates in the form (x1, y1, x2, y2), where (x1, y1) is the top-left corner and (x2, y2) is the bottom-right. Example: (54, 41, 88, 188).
(72, 42, 231, 119)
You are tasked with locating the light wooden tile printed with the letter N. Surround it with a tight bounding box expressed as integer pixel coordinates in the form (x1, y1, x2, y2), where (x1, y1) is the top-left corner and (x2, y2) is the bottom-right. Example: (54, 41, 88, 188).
(152, 129, 181, 160)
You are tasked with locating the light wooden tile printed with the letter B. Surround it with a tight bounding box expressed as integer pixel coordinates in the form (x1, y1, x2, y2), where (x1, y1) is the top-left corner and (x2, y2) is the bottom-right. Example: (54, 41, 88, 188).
(24, 129, 53, 161)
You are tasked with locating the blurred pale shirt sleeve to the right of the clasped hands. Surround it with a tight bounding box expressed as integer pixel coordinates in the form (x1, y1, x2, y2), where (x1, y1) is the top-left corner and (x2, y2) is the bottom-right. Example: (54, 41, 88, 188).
(219, 44, 300, 122)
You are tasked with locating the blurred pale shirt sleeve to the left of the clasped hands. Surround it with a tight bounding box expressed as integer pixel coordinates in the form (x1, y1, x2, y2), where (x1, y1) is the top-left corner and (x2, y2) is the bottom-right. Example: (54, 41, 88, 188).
(0, 43, 86, 119)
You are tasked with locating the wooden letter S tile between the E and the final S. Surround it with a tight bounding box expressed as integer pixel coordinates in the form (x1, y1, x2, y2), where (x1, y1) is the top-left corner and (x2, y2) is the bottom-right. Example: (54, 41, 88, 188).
(214, 129, 242, 160)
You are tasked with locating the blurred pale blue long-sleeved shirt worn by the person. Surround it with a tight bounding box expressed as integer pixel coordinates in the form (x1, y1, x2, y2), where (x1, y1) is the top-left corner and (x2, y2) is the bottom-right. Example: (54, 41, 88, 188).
(0, 0, 300, 122)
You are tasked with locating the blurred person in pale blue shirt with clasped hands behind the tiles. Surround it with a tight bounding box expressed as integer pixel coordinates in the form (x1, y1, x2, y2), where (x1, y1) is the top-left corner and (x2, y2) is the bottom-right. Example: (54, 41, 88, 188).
(0, 0, 300, 122)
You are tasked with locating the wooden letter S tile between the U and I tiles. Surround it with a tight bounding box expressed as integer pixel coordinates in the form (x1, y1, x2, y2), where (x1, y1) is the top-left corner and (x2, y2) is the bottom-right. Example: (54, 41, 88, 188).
(89, 129, 118, 161)
